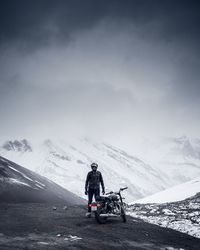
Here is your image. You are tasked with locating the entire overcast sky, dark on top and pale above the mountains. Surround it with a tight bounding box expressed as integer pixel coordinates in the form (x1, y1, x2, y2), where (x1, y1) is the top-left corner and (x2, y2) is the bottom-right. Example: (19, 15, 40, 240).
(0, 0, 200, 150)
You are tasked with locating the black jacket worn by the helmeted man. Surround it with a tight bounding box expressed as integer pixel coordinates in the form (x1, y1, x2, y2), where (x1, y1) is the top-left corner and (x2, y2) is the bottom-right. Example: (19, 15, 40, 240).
(85, 171, 105, 191)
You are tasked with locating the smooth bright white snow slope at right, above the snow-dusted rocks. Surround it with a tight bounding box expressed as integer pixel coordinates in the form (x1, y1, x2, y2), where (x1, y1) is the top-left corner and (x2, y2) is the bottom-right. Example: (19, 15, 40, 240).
(133, 177, 200, 204)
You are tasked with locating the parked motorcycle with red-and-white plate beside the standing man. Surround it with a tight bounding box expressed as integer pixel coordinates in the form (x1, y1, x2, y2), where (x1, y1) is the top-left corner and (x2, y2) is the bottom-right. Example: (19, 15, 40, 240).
(90, 187, 128, 224)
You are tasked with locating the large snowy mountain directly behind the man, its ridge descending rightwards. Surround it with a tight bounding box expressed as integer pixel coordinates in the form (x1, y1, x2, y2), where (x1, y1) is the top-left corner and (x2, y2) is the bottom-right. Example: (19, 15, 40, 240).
(0, 138, 172, 202)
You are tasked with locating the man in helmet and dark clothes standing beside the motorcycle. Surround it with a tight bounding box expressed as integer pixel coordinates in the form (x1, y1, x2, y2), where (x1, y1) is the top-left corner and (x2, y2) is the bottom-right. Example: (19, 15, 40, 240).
(85, 163, 105, 217)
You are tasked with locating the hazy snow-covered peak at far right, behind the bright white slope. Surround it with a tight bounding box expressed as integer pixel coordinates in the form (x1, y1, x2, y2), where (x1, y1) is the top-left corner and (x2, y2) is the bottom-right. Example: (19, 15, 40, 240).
(140, 136, 200, 185)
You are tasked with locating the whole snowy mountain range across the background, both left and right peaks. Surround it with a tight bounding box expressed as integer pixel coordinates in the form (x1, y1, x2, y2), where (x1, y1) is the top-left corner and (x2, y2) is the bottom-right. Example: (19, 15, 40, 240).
(0, 136, 200, 202)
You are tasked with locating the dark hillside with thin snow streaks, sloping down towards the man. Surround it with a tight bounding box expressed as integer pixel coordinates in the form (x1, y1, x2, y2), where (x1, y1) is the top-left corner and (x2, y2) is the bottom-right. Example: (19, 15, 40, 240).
(0, 156, 86, 205)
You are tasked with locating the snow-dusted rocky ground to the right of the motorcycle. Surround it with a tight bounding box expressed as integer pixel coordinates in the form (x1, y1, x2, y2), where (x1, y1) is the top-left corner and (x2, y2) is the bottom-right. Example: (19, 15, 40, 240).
(128, 193, 200, 238)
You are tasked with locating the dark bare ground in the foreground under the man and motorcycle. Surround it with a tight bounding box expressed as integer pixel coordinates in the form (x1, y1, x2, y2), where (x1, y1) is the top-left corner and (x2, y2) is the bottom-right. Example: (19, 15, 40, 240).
(0, 203, 200, 250)
